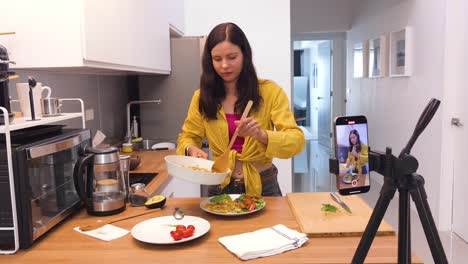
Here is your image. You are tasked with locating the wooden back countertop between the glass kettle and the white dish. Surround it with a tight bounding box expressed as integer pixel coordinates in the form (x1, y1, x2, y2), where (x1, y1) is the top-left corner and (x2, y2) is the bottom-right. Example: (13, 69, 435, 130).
(130, 150, 175, 194)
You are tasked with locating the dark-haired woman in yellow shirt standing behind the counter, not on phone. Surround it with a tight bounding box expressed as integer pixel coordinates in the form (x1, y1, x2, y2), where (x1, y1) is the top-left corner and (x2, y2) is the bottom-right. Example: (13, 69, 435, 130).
(177, 23, 305, 196)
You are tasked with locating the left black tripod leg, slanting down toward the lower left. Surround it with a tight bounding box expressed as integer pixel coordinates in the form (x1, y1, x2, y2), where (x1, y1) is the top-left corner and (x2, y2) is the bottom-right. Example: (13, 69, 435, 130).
(351, 177, 396, 264)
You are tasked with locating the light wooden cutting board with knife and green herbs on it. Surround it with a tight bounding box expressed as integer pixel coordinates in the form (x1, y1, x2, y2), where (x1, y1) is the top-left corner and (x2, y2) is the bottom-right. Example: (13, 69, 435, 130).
(287, 193, 395, 237)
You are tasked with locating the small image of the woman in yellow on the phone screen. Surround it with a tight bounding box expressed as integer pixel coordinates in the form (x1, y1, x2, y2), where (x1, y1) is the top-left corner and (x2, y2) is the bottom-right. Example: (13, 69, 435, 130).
(346, 129, 369, 174)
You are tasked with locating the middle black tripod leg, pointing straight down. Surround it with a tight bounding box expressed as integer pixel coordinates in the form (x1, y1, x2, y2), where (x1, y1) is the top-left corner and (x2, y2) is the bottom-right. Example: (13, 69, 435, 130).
(398, 189, 411, 264)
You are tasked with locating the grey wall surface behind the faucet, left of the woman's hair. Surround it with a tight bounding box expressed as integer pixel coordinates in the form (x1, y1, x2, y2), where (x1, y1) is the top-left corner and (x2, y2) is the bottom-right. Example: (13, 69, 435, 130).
(138, 37, 203, 143)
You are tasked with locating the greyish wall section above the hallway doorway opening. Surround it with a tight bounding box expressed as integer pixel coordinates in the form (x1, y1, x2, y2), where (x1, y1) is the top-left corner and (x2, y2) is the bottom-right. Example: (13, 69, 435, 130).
(291, 0, 355, 32)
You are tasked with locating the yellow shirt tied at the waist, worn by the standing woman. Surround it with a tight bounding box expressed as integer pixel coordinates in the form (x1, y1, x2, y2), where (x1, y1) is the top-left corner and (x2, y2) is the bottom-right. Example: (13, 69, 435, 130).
(177, 80, 305, 195)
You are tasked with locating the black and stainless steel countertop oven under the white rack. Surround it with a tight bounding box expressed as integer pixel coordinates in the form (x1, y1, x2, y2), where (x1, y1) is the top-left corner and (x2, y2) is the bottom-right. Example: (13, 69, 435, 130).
(0, 129, 91, 249)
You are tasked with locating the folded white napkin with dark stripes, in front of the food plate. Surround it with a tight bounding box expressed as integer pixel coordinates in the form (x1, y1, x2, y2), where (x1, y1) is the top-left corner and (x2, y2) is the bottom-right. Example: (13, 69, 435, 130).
(219, 225, 309, 260)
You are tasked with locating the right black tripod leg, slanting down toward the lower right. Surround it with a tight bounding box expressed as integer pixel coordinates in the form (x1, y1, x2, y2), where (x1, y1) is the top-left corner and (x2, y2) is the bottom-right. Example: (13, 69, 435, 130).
(410, 174, 448, 264)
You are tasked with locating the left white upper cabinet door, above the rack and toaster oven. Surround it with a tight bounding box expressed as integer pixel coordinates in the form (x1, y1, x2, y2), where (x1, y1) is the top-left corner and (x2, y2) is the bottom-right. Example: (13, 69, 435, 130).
(0, 0, 83, 69)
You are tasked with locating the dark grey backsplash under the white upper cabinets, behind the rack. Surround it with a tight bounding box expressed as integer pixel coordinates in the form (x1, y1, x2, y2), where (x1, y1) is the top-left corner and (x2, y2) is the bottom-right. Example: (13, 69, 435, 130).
(9, 70, 128, 138)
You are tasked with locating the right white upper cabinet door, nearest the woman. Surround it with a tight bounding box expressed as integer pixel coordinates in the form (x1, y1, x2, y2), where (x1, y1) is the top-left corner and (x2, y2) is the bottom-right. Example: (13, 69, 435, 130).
(82, 0, 170, 73)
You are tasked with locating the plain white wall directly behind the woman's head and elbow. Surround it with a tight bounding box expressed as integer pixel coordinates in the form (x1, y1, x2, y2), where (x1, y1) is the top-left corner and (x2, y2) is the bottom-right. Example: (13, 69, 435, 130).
(185, 0, 292, 194)
